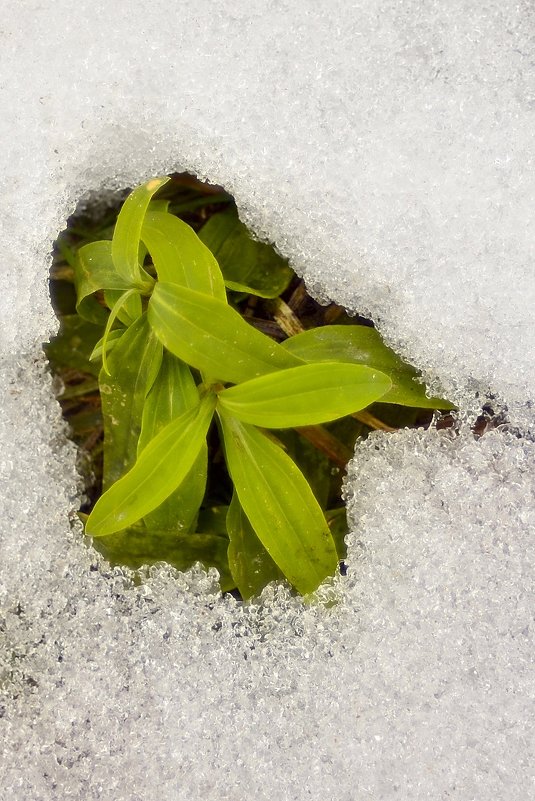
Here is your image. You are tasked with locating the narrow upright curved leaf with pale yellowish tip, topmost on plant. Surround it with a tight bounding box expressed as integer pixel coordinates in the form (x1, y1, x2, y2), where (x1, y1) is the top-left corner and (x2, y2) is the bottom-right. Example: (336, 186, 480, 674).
(111, 178, 169, 289)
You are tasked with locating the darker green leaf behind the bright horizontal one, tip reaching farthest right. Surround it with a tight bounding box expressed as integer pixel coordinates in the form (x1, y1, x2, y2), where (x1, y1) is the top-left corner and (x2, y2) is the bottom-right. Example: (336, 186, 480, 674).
(281, 325, 454, 409)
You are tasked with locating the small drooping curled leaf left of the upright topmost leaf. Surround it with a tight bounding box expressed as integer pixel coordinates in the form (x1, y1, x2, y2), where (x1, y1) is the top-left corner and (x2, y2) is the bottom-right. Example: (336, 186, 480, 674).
(74, 240, 132, 325)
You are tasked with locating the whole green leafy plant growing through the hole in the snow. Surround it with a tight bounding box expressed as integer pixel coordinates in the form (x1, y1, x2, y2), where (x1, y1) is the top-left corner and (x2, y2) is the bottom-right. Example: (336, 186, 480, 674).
(48, 178, 451, 598)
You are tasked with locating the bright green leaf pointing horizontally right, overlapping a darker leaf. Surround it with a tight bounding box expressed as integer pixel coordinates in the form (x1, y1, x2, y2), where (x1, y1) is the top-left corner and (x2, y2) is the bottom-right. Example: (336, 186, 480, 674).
(219, 362, 392, 428)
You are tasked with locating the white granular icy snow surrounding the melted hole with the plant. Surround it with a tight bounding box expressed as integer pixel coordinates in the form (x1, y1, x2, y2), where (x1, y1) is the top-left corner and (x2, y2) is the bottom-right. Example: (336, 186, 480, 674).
(0, 0, 535, 801)
